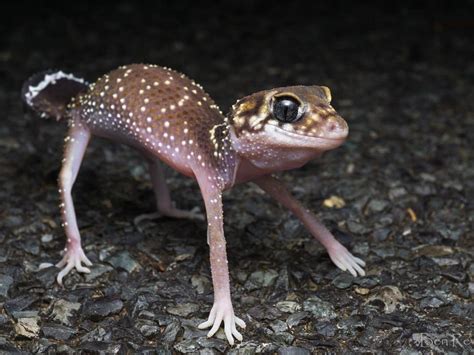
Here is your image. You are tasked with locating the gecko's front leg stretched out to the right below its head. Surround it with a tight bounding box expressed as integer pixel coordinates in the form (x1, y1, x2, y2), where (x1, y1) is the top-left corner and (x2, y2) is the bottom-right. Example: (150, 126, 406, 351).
(254, 176, 365, 276)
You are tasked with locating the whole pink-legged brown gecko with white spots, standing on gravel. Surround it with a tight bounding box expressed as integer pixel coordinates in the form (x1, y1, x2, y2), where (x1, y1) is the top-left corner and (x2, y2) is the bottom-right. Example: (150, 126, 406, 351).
(22, 64, 365, 345)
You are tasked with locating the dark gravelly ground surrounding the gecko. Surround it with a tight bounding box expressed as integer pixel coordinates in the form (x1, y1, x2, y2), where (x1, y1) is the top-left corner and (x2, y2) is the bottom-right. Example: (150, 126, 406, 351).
(0, 1, 474, 354)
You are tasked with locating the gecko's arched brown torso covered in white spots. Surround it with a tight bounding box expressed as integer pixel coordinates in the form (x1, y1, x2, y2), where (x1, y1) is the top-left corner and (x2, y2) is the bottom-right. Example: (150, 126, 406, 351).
(70, 64, 235, 186)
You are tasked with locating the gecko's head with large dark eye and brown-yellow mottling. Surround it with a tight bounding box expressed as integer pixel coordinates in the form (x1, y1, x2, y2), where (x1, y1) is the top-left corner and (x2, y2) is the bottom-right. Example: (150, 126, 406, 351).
(229, 86, 349, 168)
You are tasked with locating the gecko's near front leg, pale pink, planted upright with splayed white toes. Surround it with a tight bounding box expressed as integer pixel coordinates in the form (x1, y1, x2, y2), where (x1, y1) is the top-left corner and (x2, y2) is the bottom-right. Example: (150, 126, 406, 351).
(194, 179, 245, 345)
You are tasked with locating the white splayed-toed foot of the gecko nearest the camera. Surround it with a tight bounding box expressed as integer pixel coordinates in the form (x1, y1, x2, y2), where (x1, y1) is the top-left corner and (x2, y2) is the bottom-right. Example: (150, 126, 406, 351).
(198, 300, 245, 345)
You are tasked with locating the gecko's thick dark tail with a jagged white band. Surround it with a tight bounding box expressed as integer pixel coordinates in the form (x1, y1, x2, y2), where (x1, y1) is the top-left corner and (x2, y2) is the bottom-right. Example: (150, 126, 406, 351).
(21, 70, 88, 120)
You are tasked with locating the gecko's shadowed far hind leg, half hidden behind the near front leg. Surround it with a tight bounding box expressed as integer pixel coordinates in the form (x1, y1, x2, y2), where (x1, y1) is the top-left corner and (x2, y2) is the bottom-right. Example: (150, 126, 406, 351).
(133, 159, 204, 225)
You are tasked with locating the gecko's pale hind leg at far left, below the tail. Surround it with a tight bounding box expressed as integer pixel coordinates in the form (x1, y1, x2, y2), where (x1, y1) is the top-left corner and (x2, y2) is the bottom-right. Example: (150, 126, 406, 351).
(56, 121, 92, 285)
